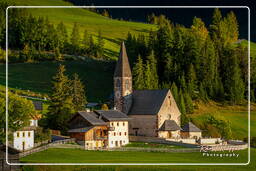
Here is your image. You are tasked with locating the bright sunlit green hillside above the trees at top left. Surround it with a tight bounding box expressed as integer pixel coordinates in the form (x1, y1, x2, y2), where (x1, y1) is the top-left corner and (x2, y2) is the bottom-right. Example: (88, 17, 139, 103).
(15, 0, 156, 59)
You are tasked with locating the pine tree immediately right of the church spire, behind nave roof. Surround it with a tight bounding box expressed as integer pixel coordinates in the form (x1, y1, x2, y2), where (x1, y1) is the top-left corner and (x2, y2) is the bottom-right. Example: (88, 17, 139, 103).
(132, 55, 145, 90)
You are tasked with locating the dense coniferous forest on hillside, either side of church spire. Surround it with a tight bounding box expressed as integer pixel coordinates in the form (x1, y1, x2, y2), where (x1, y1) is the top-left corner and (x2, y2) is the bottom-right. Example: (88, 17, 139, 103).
(0, 3, 253, 113)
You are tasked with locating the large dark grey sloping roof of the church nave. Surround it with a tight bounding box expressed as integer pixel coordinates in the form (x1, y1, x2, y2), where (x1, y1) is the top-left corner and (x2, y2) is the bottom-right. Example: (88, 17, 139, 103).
(128, 89, 169, 115)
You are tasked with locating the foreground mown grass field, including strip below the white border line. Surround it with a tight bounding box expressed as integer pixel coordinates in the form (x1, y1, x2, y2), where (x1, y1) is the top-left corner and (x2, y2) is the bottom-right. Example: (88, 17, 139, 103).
(21, 148, 256, 171)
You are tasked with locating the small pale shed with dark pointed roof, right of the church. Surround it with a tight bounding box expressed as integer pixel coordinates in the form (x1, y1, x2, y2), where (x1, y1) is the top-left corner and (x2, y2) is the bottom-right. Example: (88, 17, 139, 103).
(181, 122, 202, 139)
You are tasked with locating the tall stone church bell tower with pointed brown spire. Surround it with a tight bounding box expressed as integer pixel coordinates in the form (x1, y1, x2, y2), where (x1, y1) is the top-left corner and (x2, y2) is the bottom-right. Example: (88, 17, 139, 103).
(114, 42, 132, 113)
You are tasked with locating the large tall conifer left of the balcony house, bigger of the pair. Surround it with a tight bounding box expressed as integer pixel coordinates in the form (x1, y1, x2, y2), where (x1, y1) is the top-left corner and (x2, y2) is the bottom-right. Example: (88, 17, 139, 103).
(47, 65, 74, 134)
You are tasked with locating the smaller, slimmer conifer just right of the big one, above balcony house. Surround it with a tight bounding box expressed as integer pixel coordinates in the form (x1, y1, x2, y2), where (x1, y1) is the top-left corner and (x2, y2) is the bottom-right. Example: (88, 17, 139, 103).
(70, 74, 87, 111)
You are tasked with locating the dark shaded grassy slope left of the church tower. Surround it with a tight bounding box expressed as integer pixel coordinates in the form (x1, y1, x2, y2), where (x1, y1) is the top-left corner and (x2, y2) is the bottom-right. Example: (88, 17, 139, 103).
(0, 60, 114, 102)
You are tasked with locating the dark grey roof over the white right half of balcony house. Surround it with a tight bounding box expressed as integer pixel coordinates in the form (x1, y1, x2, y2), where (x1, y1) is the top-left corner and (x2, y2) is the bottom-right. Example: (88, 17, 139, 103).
(95, 110, 130, 121)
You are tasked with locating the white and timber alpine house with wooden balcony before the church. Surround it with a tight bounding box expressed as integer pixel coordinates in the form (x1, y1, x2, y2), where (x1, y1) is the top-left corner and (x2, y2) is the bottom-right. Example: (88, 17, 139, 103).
(68, 110, 129, 149)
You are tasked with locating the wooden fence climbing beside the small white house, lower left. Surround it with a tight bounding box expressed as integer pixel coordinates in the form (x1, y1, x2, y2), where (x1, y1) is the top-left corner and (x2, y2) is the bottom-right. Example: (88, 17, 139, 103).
(19, 138, 75, 157)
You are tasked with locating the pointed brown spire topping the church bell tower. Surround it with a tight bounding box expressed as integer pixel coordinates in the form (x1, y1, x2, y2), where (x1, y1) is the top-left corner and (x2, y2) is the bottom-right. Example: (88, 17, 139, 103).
(114, 42, 132, 77)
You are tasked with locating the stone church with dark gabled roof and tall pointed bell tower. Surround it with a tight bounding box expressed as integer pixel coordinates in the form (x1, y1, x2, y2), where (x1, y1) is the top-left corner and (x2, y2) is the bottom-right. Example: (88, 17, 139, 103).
(114, 42, 181, 138)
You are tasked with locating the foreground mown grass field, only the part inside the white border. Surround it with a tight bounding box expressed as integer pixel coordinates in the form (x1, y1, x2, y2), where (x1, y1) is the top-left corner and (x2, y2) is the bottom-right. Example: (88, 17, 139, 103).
(21, 148, 250, 163)
